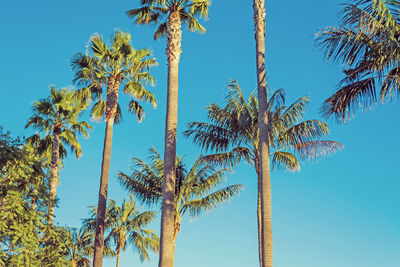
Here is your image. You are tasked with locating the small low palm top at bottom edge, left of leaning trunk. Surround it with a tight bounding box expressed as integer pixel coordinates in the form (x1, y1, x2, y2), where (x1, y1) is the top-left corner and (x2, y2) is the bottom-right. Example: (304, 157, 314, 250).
(65, 228, 93, 267)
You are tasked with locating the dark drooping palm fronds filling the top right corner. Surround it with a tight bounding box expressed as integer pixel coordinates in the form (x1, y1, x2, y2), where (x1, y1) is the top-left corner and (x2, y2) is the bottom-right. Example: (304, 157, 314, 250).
(316, 0, 400, 122)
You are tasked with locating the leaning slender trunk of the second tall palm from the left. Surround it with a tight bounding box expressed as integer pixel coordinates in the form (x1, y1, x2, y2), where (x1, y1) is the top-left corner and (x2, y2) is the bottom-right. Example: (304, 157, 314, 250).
(93, 77, 119, 267)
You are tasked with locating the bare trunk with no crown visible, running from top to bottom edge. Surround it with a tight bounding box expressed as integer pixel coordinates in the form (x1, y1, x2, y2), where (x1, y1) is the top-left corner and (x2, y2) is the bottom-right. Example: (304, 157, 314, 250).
(253, 0, 272, 267)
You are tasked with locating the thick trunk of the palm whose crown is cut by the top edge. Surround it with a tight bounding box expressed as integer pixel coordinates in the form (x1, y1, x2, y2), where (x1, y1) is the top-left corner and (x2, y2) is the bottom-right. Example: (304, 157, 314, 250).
(158, 11, 182, 267)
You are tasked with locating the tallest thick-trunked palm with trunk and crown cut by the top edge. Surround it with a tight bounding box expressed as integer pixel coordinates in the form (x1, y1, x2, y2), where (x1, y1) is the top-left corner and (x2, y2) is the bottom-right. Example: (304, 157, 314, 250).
(127, 0, 210, 267)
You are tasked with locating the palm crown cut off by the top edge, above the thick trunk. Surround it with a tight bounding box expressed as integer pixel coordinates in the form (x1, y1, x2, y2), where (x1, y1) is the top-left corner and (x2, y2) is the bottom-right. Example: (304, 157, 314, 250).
(127, 0, 210, 40)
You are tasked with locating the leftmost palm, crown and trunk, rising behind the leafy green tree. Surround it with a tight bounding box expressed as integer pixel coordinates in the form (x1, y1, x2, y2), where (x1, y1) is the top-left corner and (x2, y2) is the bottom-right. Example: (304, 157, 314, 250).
(25, 87, 91, 224)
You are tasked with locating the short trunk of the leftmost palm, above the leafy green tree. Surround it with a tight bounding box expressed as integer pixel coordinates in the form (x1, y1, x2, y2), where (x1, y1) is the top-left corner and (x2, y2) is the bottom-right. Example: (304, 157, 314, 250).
(47, 133, 61, 225)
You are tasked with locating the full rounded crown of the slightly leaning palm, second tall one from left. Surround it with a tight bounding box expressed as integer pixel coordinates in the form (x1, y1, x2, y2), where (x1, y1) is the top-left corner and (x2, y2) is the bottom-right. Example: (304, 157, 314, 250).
(72, 32, 157, 123)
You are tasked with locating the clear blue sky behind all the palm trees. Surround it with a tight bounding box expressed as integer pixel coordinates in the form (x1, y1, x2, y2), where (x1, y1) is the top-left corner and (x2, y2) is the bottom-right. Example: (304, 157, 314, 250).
(0, 0, 400, 267)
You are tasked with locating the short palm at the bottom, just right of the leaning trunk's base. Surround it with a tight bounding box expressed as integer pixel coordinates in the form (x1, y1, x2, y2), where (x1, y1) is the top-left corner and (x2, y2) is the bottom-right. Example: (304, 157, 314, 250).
(84, 197, 159, 267)
